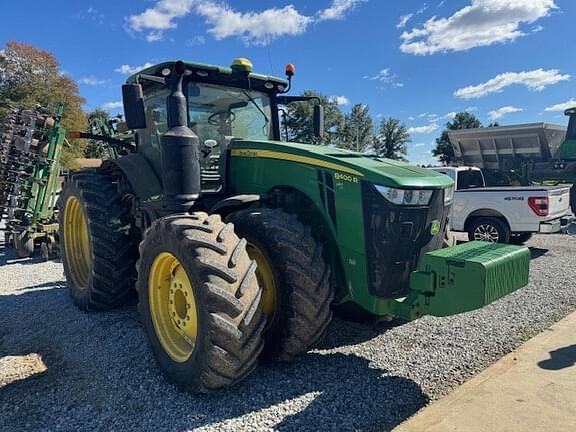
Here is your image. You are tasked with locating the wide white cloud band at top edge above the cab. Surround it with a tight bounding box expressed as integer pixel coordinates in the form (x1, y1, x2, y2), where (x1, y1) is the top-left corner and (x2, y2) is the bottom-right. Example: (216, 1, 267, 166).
(126, 0, 365, 45)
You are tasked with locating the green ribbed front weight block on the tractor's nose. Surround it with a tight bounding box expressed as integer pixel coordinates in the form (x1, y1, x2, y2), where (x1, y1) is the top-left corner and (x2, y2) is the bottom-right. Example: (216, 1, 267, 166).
(398, 241, 530, 319)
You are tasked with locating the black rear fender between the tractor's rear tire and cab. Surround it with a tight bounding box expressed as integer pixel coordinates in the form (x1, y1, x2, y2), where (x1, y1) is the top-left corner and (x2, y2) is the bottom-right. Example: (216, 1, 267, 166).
(109, 153, 162, 201)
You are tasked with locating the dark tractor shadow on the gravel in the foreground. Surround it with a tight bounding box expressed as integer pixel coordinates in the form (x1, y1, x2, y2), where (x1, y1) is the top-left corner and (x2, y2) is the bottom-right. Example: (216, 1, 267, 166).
(0, 282, 429, 432)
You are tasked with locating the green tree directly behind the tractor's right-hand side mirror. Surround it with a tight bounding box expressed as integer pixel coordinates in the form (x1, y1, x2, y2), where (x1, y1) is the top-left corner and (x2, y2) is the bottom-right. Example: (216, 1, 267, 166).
(284, 90, 344, 145)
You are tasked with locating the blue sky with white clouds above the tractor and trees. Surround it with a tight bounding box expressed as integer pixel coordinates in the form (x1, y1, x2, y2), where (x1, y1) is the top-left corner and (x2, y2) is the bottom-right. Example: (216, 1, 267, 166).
(0, 0, 576, 163)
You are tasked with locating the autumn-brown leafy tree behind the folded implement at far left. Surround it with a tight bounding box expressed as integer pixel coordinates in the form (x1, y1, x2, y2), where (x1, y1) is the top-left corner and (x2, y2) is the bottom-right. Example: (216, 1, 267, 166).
(0, 41, 87, 166)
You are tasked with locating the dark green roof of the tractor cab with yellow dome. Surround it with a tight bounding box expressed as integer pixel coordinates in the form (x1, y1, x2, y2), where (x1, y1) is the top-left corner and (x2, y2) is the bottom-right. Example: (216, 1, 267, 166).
(126, 59, 288, 93)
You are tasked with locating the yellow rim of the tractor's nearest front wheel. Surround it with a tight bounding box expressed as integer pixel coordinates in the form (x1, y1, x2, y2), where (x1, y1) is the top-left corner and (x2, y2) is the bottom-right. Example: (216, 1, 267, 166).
(148, 252, 198, 363)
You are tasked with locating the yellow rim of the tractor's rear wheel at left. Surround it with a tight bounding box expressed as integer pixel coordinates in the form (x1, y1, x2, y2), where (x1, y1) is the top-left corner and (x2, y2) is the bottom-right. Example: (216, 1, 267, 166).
(64, 196, 92, 288)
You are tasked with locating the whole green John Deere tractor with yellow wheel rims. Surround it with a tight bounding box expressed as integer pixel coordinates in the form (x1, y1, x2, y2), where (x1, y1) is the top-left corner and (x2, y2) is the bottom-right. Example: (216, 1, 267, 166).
(59, 59, 530, 392)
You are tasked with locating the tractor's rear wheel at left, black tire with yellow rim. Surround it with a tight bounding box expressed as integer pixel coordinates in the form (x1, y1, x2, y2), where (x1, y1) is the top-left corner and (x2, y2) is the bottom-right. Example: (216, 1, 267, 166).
(58, 172, 135, 310)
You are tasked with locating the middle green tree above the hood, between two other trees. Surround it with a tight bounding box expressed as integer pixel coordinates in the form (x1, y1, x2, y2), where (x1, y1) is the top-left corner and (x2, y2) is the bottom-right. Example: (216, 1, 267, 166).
(338, 104, 374, 151)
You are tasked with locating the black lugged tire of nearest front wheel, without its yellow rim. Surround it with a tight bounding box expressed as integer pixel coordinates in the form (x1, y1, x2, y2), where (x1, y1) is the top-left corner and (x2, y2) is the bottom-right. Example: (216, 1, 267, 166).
(136, 213, 265, 393)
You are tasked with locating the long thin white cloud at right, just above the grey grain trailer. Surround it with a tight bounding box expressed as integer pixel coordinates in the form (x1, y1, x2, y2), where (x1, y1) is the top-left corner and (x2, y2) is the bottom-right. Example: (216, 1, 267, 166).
(454, 69, 570, 99)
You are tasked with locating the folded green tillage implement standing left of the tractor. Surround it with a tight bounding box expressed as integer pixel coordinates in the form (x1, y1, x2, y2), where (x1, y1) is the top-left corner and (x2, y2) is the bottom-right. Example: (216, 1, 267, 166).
(0, 105, 66, 258)
